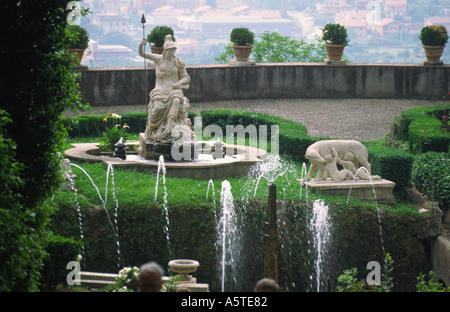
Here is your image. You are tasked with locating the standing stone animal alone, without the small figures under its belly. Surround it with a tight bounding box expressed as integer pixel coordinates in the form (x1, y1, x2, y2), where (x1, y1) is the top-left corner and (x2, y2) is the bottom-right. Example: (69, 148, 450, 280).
(305, 140, 371, 181)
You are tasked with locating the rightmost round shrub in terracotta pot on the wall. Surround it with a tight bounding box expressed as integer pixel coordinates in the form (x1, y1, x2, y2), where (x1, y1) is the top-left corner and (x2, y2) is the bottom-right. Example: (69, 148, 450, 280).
(419, 25, 448, 62)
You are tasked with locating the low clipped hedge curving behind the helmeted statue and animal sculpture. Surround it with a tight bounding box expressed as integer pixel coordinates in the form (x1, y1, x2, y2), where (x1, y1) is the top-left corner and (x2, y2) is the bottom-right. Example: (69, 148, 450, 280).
(64, 110, 413, 191)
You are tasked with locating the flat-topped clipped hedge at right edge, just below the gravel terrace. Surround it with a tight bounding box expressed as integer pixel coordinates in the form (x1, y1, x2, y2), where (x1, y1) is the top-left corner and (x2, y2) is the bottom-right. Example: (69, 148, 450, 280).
(394, 105, 450, 154)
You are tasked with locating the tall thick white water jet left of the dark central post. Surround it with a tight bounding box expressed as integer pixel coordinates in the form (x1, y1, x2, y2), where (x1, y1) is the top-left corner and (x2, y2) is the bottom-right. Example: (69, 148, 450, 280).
(218, 180, 236, 292)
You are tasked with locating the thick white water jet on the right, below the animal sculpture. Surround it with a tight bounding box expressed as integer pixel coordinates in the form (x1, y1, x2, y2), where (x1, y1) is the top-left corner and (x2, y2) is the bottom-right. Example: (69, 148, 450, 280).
(310, 199, 330, 292)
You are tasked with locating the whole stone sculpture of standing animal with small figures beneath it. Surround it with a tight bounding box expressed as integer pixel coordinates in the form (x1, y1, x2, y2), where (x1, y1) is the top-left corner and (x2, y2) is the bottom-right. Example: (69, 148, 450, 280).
(305, 140, 371, 181)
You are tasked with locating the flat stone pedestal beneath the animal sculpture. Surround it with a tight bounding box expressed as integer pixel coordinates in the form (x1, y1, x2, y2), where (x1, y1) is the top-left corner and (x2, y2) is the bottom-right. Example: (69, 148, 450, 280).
(298, 178, 395, 205)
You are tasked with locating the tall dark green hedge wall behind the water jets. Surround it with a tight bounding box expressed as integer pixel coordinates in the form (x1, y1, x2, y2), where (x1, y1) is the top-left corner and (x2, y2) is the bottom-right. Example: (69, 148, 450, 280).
(53, 191, 428, 291)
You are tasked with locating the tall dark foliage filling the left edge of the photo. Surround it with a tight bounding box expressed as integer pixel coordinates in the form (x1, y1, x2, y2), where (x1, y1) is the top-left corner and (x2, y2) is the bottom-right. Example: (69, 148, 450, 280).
(0, 0, 89, 291)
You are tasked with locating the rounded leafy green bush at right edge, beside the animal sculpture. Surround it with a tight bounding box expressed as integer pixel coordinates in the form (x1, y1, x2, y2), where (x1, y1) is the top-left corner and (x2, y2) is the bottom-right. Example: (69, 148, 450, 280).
(412, 152, 450, 212)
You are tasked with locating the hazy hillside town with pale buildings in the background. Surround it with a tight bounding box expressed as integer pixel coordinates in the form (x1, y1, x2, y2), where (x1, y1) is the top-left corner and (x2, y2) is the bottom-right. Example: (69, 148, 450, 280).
(80, 0, 450, 67)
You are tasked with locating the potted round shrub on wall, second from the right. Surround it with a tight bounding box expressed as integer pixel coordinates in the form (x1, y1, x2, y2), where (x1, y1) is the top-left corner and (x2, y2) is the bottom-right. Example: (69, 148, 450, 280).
(322, 23, 349, 61)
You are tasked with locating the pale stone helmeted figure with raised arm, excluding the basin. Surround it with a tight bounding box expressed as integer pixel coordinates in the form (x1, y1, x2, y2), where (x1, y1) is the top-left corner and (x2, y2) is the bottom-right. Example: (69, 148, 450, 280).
(139, 35, 194, 142)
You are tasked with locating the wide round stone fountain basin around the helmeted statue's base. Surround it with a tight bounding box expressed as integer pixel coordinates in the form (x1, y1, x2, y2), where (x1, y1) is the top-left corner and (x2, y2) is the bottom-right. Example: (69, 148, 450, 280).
(64, 141, 266, 180)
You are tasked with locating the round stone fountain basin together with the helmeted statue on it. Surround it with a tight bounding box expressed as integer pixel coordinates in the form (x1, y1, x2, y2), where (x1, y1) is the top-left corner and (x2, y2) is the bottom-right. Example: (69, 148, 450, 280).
(65, 35, 266, 180)
